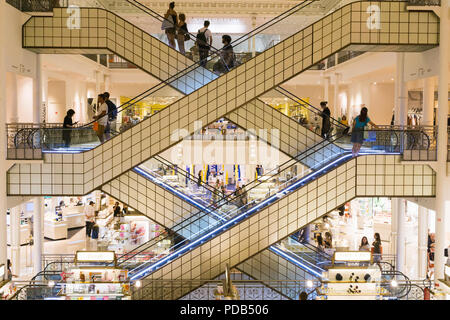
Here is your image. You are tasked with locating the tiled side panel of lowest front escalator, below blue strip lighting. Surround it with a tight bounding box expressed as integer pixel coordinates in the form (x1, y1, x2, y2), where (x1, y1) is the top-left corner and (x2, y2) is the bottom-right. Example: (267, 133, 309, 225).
(135, 155, 435, 300)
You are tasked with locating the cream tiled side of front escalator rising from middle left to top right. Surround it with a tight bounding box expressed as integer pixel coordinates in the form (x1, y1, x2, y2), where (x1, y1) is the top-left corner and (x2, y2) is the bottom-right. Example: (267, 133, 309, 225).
(8, 2, 437, 195)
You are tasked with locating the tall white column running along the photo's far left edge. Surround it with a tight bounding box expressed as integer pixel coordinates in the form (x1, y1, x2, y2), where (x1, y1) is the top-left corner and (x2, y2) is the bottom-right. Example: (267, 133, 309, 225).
(0, 1, 8, 265)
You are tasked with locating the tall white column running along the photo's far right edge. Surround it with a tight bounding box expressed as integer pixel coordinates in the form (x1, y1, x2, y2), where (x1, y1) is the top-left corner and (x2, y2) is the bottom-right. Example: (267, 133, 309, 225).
(434, 0, 450, 279)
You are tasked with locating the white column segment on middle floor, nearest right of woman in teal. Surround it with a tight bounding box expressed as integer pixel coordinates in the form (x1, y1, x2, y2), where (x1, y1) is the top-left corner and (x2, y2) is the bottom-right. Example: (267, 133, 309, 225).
(395, 52, 408, 125)
